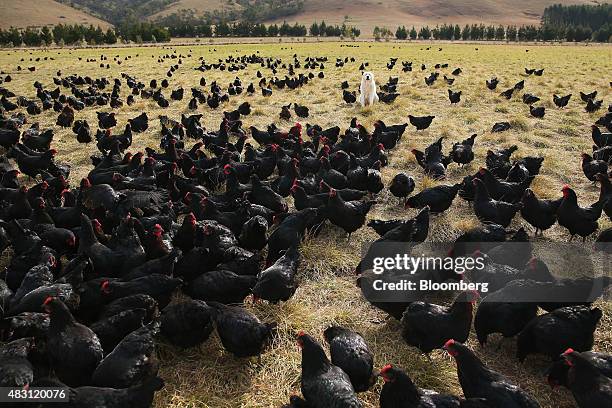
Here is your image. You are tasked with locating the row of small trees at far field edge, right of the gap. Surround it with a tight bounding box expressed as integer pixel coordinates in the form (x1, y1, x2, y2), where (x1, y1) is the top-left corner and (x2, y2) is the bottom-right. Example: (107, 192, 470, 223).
(390, 24, 612, 42)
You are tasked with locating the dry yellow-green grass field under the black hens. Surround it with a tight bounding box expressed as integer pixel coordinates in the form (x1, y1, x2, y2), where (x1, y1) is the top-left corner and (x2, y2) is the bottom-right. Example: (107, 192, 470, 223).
(0, 43, 612, 408)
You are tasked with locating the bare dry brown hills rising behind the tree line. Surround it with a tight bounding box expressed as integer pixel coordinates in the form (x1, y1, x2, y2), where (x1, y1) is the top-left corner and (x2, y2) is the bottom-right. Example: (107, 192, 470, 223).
(0, 0, 598, 35)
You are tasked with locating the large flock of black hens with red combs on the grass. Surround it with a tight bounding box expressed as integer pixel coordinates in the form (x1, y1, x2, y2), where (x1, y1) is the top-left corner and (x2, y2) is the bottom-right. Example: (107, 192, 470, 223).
(0, 45, 612, 408)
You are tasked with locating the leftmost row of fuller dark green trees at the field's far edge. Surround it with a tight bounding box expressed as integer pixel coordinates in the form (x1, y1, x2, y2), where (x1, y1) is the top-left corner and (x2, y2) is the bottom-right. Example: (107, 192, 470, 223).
(0, 23, 170, 47)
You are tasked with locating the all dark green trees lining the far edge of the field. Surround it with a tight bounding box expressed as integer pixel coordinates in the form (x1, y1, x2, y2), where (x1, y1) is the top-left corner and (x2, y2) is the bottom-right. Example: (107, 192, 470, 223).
(0, 0, 612, 47)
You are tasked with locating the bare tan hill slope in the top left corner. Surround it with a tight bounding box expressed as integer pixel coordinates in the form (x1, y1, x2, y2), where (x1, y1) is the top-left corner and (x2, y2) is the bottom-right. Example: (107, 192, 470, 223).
(0, 0, 110, 28)
